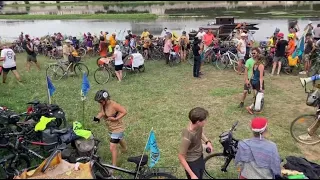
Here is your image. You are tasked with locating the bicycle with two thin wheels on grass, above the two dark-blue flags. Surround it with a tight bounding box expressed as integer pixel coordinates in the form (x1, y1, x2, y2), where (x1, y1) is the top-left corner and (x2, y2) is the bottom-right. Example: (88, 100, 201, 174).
(46, 59, 89, 81)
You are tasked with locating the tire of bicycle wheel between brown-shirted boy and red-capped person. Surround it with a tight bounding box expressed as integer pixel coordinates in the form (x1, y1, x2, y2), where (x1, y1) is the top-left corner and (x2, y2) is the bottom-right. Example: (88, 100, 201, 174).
(204, 153, 237, 179)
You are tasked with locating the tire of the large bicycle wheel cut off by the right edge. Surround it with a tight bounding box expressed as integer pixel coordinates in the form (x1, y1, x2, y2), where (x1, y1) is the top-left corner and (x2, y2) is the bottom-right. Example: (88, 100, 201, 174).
(290, 114, 320, 145)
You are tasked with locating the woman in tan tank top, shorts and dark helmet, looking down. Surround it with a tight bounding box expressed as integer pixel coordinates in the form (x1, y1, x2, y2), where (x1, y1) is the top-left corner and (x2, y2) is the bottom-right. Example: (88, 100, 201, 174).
(93, 90, 127, 170)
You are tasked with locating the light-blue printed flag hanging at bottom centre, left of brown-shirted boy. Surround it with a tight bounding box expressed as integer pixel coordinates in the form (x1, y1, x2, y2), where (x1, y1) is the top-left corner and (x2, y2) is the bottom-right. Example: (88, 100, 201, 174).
(145, 130, 160, 168)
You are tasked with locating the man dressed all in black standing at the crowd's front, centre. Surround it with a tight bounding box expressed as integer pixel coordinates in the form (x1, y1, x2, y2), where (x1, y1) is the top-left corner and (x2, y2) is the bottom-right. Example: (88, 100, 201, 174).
(192, 37, 203, 78)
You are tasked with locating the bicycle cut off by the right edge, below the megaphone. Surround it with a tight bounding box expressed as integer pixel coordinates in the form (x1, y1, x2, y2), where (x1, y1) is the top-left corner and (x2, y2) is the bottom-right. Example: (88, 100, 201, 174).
(290, 81, 320, 145)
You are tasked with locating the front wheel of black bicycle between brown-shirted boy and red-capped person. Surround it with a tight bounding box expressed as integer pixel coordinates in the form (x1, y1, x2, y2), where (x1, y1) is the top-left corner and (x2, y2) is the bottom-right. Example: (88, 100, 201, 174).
(204, 153, 238, 179)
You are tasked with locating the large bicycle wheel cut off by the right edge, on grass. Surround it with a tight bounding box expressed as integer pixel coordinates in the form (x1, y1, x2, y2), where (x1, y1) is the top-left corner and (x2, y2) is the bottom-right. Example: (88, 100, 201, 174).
(290, 114, 320, 145)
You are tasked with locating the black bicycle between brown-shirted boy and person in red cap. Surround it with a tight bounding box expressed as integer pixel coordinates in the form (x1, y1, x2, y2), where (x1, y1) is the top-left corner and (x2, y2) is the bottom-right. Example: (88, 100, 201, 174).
(204, 121, 239, 179)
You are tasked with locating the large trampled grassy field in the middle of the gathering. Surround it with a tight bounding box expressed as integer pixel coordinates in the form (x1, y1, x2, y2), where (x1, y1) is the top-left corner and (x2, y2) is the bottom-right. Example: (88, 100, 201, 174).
(0, 54, 319, 178)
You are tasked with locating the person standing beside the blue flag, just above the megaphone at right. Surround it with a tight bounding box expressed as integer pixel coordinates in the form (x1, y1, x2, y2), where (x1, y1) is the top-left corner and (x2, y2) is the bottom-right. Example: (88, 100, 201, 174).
(299, 33, 316, 74)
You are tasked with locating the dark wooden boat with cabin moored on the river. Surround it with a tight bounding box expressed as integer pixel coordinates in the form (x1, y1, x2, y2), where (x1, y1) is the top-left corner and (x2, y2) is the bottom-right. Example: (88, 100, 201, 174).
(189, 16, 259, 40)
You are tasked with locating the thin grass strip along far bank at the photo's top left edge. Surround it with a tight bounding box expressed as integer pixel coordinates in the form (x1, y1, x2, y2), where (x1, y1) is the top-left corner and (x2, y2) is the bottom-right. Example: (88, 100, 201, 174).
(6, 1, 165, 7)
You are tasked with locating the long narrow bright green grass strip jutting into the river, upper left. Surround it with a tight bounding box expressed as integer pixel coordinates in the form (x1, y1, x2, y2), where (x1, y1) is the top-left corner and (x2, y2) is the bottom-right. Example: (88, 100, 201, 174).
(0, 13, 158, 20)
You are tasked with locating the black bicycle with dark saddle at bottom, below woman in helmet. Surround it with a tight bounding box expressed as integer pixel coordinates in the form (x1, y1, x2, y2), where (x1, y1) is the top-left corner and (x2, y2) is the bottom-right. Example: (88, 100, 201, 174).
(76, 139, 176, 179)
